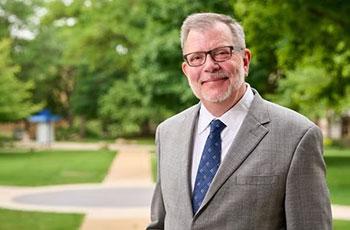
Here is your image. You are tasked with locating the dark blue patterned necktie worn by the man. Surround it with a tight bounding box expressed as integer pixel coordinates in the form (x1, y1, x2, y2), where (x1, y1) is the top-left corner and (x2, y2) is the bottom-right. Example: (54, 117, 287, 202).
(192, 120, 226, 213)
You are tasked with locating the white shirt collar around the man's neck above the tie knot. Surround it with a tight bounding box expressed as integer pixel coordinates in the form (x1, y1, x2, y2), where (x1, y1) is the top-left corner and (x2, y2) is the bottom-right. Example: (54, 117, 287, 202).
(197, 83, 254, 134)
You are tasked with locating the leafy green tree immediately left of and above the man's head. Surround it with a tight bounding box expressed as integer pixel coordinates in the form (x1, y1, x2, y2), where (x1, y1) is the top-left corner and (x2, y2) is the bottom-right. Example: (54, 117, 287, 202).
(100, 0, 232, 135)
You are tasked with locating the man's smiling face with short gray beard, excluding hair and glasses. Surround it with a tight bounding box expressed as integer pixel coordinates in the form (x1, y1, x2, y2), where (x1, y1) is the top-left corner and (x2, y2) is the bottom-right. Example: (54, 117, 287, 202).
(182, 23, 250, 103)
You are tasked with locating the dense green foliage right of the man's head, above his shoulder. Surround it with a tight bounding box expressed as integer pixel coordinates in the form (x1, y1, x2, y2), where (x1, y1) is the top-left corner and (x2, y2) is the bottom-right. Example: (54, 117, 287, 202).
(234, 0, 350, 119)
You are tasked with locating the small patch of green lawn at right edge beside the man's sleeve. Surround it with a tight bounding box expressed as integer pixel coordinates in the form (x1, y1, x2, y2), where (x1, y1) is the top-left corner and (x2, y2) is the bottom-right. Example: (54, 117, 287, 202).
(325, 148, 350, 205)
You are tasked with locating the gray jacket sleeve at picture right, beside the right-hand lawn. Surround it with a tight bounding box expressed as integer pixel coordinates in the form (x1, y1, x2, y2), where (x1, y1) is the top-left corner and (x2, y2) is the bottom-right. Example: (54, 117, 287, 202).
(285, 126, 332, 230)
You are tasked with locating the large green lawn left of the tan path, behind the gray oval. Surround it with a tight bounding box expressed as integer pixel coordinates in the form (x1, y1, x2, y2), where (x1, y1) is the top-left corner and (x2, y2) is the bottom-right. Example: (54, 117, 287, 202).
(0, 150, 115, 186)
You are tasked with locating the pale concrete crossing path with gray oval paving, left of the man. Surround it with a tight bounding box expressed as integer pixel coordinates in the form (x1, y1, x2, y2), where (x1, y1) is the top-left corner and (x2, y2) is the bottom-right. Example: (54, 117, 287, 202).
(0, 183, 153, 214)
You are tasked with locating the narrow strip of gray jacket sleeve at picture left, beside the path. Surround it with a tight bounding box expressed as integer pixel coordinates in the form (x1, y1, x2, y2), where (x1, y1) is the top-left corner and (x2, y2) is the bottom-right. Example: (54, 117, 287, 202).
(146, 127, 166, 230)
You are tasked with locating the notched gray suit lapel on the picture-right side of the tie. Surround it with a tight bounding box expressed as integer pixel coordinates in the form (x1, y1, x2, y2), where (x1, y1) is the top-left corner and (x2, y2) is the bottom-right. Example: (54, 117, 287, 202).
(195, 91, 270, 216)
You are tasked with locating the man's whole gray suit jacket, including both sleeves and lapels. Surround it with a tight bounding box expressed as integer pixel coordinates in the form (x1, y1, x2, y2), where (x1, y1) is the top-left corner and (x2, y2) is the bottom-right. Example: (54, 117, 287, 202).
(147, 91, 332, 230)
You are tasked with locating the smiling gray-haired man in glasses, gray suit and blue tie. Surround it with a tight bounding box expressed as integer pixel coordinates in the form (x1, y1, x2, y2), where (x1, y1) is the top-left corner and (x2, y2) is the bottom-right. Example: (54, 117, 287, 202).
(147, 13, 332, 230)
